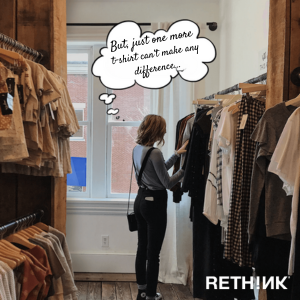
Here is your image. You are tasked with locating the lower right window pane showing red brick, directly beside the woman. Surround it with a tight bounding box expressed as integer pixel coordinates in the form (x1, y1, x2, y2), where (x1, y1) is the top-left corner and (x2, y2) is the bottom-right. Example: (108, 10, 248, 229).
(111, 126, 138, 194)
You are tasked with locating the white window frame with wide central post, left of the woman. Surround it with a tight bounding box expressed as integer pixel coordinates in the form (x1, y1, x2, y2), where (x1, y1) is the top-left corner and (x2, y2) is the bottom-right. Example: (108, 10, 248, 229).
(67, 40, 150, 202)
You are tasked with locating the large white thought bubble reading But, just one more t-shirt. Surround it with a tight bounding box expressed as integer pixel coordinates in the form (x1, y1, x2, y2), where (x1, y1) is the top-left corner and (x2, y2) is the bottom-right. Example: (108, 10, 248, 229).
(92, 20, 216, 90)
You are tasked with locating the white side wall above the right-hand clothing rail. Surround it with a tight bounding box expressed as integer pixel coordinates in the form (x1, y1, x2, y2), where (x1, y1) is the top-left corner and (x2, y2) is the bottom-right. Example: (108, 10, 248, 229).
(215, 0, 269, 92)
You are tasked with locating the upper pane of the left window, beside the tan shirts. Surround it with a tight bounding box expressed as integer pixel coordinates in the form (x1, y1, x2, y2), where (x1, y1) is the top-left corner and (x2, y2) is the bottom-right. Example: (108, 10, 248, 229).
(67, 53, 88, 121)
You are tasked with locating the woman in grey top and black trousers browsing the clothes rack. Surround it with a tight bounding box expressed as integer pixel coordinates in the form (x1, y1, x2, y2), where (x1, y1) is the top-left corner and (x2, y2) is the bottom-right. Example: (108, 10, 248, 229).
(133, 115, 188, 300)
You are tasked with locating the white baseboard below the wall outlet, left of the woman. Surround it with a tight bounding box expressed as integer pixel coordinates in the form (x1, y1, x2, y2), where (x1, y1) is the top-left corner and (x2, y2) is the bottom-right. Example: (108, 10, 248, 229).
(71, 253, 136, 273)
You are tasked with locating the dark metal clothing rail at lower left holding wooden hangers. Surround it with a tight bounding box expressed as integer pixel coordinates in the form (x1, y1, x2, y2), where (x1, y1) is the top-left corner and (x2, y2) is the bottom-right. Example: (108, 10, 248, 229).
(0, 210, 44, 239)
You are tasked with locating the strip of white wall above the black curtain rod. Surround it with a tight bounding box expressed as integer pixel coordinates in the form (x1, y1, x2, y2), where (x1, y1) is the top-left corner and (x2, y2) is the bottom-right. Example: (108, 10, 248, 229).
(67, 0, 218, 23)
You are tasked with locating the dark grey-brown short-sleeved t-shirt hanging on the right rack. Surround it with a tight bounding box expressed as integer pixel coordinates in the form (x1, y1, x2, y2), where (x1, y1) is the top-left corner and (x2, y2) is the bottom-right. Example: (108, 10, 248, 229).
(249, 103, 296, 242)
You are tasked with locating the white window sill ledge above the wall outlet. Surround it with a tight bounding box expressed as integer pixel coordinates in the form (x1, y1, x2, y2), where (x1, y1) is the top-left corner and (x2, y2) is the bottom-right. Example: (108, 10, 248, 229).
(67, 197, 134, 216)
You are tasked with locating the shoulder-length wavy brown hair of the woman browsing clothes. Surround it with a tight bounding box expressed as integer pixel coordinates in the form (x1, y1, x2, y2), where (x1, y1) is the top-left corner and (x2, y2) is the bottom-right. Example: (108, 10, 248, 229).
(136, 115, 166, 146)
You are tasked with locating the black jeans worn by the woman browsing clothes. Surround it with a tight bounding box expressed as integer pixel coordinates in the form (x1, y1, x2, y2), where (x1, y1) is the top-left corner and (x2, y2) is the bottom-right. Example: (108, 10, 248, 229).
(134, 188, 168, 297)
